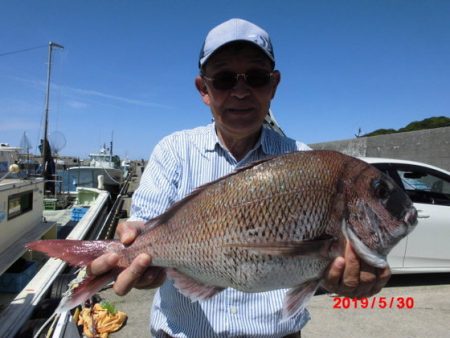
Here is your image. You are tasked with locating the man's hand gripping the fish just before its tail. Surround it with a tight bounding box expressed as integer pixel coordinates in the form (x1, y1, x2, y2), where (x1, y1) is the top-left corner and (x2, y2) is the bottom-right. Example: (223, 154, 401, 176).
(88, 222, 166, 296)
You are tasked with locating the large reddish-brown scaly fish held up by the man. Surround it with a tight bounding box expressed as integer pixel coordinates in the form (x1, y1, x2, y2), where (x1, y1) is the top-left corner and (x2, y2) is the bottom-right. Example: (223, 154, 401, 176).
(27, 151, 417, 318)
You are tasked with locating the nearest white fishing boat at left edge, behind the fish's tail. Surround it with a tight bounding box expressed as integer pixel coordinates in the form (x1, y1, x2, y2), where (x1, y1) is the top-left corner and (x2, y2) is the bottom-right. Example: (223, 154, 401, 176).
(0, 147, 117, 337)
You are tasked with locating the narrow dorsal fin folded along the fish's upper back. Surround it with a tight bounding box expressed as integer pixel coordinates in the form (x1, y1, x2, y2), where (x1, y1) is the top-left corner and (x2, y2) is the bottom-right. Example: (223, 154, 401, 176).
(142, 156, 286, 228)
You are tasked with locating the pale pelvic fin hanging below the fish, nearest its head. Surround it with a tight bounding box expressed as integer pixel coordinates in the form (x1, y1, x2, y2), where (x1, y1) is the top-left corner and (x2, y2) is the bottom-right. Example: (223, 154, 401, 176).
(283, 279, 320, 321)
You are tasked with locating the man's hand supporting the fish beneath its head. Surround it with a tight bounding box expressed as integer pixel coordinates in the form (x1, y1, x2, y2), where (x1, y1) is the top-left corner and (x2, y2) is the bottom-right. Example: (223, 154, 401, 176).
(322, 242, 391, 297)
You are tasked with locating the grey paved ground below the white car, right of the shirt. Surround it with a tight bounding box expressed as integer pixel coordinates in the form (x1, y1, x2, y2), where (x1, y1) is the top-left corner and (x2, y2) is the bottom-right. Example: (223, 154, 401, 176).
(302, 274, 450, 338)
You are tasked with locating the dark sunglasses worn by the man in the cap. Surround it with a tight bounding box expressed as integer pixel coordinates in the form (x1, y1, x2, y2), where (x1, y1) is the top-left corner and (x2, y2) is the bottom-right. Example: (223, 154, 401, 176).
(201, 69, 273, 90)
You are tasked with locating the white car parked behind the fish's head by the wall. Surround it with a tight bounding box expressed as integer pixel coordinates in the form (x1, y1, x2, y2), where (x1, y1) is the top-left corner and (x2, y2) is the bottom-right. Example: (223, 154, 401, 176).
(361, 157, 450, 273)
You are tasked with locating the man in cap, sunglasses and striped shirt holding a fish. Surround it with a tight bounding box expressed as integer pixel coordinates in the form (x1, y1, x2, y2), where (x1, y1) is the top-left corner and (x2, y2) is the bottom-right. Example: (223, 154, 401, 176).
(89, 19, 390, 337)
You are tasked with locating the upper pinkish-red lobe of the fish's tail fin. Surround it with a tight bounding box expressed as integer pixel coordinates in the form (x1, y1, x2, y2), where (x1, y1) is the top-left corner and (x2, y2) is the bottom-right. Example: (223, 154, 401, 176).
(25, 239, 123, 267)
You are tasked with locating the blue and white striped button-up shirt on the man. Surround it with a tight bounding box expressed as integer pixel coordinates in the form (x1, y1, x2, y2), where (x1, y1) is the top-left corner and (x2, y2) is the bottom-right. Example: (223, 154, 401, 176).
(130, 124, 309, 337)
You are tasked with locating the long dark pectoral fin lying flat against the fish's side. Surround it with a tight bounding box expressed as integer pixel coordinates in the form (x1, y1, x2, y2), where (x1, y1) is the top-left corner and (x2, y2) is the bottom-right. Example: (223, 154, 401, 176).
(230, 237, 335, 258)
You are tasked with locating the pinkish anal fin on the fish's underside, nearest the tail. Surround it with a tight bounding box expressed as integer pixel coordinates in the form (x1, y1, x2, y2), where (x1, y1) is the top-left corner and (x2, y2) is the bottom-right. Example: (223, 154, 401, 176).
(166, 268, 224, 302)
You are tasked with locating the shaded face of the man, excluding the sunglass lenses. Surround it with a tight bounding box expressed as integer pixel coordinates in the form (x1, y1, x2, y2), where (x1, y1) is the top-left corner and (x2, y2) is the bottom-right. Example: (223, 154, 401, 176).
(196, 43, 280, 140)
